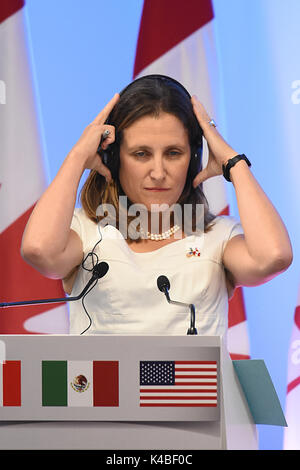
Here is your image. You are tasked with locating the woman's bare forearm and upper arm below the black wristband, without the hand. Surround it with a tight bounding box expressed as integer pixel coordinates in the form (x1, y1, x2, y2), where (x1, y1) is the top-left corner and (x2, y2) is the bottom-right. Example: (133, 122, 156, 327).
(223, 161, 293, 286)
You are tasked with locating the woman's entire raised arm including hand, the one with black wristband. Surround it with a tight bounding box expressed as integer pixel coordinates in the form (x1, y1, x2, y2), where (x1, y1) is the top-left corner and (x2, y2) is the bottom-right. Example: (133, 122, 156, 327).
(192, 97, 293, 286)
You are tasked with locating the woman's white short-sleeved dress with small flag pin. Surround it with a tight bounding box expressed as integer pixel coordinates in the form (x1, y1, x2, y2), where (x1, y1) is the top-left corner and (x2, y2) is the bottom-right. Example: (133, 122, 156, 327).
(69, 208, 243, 336)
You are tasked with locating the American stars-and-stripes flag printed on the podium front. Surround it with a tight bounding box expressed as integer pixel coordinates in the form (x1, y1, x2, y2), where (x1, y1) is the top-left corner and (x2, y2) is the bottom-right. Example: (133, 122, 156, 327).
(140, 361, 217, 407)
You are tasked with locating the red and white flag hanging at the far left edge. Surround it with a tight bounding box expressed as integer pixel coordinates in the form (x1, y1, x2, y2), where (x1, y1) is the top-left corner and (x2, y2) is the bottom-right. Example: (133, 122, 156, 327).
(0, 0, 68, 334)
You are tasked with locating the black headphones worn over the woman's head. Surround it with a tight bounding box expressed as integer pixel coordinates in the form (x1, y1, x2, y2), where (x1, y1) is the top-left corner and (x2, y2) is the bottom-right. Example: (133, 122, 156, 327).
(97, 74, 203, 180)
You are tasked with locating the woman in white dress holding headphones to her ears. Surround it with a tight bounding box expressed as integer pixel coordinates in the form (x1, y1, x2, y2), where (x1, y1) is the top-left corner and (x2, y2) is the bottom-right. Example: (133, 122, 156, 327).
(22, 76, 292, 336)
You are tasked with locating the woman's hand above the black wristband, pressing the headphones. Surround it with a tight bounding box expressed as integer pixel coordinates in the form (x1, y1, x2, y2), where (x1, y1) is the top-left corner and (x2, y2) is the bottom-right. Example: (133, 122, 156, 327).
(191, 95, 238, 188)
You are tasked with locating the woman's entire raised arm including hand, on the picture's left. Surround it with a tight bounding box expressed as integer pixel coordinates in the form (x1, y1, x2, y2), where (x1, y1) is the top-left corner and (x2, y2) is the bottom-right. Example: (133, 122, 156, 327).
(21, 94, 119, 279)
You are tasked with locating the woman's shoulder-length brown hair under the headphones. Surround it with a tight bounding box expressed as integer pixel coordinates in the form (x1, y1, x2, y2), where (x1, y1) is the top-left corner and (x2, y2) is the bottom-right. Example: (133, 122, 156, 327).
(80, 76, 215, 241)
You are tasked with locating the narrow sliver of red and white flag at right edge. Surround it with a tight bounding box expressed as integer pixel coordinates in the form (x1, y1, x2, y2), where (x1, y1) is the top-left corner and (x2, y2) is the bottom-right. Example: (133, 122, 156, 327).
(283, 288, 300, 450)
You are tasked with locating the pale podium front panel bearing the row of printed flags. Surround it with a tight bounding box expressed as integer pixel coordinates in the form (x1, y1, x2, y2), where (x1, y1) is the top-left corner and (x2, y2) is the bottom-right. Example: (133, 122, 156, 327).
(0, 335, 220, 422)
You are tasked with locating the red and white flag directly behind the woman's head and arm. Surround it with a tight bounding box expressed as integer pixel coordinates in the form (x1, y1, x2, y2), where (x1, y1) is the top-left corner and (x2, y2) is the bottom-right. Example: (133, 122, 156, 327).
(134, 0, 250, 359)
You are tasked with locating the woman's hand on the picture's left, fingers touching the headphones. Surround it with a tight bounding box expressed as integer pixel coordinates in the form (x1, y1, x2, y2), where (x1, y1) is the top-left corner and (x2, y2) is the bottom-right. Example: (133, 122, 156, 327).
(70, 93, 120, 181)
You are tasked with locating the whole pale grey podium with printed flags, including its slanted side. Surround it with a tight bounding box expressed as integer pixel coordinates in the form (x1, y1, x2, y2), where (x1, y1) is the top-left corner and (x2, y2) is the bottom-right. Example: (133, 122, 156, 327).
(0, 335, 258, 450)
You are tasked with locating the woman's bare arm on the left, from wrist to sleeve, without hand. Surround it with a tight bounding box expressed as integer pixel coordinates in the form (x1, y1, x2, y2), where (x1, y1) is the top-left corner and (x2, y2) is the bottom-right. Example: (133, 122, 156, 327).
(21, 152, 84, 279)
